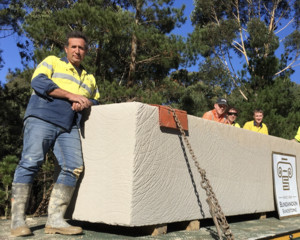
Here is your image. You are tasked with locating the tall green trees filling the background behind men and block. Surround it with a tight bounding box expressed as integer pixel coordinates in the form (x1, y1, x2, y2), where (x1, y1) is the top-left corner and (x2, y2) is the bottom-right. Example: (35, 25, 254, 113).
(0, 0, 300, 217)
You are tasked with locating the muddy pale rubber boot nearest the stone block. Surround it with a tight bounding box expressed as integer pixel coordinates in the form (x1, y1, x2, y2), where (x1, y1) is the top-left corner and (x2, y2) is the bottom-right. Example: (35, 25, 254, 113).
(45, 184, 82, 235)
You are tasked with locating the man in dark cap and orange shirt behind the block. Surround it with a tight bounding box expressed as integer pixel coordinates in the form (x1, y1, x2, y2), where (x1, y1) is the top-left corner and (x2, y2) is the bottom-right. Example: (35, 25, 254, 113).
(202, 98, 228, 124)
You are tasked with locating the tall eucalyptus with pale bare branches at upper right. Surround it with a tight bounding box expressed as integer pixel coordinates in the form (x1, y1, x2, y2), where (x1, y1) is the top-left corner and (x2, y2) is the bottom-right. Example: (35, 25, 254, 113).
(189, 0, 300, 99)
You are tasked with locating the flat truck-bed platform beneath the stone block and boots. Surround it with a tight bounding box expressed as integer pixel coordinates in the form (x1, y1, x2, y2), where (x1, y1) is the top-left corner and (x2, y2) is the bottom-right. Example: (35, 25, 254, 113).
(0, 213, 300, 240)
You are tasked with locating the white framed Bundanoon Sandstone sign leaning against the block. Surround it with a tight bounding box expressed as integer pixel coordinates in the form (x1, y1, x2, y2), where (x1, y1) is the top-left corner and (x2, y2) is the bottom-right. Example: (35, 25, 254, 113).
(273, 153, 300, 217)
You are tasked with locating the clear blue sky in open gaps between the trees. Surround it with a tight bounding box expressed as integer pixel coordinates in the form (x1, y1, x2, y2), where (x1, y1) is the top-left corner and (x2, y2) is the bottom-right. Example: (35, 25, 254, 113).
(0, 0, 300, 84)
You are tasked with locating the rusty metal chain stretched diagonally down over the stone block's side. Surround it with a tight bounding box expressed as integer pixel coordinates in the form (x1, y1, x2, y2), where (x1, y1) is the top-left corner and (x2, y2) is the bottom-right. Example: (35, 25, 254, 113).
(169, 106, 234, 240)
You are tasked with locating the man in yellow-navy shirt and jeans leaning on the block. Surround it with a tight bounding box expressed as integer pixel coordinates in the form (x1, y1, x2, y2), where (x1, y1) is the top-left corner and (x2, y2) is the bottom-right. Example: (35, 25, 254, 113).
(11, 32, 100, 236)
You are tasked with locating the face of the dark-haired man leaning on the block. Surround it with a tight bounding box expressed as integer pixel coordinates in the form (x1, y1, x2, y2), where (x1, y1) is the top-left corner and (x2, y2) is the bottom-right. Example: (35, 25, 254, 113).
(65, 38, 86, 67)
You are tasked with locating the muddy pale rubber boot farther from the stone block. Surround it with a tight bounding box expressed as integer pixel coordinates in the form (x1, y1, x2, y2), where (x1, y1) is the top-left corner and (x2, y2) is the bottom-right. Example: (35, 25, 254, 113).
(10, 183, 32, 237)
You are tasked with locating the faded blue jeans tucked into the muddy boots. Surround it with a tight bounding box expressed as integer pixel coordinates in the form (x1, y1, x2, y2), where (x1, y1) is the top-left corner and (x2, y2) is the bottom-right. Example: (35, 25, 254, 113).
(14, 117, 83, 187)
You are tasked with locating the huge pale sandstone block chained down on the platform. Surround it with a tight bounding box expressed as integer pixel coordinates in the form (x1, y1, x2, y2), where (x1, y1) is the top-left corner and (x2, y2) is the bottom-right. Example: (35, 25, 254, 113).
(72, 102, 300, 226)
